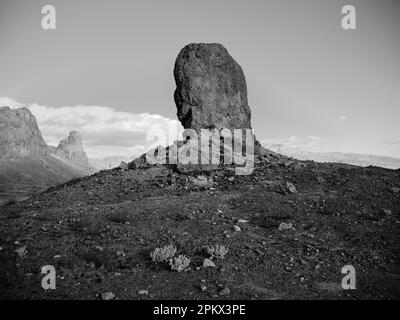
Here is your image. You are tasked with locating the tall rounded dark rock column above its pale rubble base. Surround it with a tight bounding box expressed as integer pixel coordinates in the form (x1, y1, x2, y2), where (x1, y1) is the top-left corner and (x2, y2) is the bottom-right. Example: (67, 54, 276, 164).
(174, 43, 251, 131)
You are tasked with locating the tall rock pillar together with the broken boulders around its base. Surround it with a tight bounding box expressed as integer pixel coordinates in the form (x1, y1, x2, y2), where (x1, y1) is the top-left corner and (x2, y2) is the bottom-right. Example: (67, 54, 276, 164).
(130, 43, 274, 174)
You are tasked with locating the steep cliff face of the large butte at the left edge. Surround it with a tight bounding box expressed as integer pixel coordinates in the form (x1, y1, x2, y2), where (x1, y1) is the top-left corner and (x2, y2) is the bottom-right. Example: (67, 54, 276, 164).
(0, 107, 47, 158)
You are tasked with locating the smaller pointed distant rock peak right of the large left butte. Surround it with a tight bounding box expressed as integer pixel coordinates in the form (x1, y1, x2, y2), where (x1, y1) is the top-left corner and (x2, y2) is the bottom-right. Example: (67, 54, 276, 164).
(54, 131, 95, 171)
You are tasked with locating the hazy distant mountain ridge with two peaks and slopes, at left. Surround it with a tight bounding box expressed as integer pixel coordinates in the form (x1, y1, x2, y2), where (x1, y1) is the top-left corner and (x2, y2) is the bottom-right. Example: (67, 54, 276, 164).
(0, 107, 96, 205)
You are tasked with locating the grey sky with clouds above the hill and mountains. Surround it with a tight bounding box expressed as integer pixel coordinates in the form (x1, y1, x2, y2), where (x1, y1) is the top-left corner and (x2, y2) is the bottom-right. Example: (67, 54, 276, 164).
(0, 0, 400, 157)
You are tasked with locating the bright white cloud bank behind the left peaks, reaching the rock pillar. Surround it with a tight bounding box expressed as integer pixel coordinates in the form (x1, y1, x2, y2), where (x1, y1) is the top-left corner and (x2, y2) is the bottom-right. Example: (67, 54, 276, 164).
(0, 97, 183, 157)
